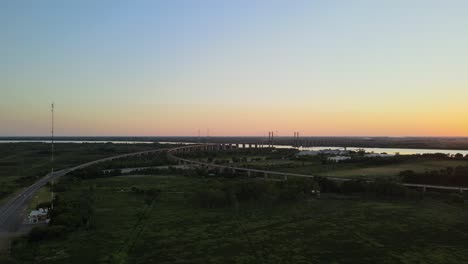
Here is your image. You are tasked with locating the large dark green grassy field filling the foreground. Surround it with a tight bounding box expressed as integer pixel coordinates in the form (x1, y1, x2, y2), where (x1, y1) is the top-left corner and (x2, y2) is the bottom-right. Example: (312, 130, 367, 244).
(10, 175, 468, 264)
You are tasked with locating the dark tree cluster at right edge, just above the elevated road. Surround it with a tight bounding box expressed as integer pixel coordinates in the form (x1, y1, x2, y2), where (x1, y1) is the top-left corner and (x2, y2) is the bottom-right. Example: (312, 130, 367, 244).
(400, 166, 468, 186)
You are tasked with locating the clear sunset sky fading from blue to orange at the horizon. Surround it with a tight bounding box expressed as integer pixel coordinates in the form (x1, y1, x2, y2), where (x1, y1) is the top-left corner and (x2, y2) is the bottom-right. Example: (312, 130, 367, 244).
(0, 0, 468, 136)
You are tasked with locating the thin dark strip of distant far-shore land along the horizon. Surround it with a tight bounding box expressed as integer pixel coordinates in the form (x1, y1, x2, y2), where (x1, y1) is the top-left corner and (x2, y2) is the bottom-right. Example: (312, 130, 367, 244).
(0, 136, 468, 151)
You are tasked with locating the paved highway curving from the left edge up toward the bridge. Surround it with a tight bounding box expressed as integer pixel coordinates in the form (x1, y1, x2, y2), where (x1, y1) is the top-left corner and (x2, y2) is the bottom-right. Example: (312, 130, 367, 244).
(0, 149, 167, 232)
